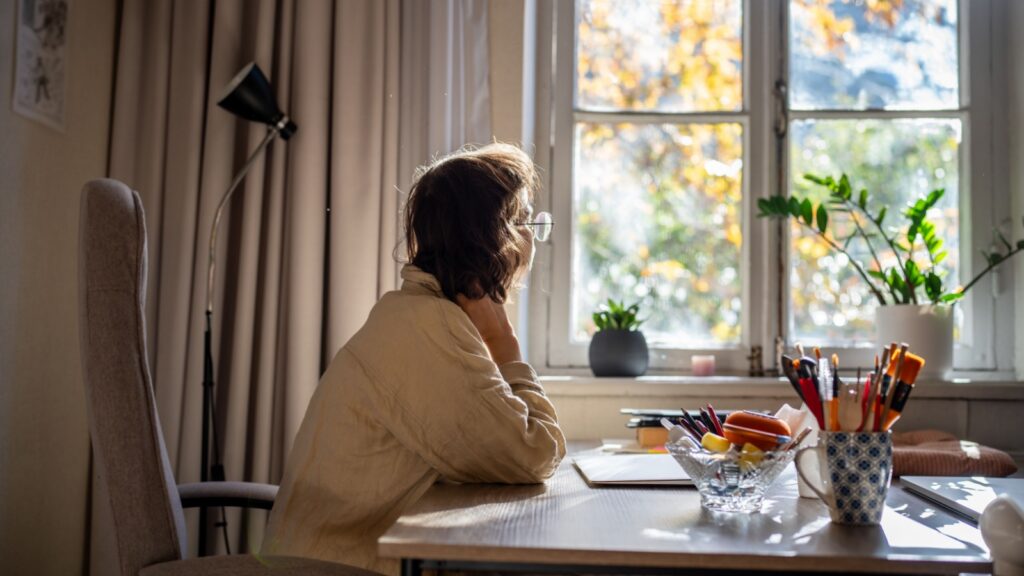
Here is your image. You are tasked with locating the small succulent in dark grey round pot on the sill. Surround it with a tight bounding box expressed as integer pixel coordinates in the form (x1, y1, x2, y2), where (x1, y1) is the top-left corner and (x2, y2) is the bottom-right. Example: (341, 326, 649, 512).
(589, 298, 647, 376)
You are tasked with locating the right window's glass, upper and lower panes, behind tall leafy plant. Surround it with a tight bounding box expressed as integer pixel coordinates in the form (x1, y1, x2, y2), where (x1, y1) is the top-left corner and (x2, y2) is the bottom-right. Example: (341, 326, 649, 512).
(788, 0, 954, 344)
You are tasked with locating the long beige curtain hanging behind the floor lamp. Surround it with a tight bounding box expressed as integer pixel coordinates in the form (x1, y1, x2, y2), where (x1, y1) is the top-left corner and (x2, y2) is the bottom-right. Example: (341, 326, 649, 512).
(91, 0, 490, 573)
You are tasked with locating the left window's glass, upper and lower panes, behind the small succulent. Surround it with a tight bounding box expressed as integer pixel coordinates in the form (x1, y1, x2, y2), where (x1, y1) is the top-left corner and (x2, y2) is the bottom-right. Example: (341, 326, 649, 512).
(569, 0, 746, 347)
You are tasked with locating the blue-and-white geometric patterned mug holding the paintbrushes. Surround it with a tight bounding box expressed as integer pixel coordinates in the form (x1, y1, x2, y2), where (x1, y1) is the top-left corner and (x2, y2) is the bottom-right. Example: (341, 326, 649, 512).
(796, 431, 893, 525)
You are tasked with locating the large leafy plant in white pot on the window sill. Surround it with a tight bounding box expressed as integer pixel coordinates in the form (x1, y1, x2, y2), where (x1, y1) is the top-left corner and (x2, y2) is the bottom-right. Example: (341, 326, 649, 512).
(758, 174, 1024, 376)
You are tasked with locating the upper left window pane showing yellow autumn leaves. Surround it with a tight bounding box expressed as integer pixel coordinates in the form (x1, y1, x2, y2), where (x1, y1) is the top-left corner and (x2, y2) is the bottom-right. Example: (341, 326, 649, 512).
(577, 0, 743, 112)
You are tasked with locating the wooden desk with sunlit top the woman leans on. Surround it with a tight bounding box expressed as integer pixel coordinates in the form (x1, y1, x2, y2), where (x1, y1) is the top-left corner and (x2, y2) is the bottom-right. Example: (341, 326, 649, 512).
(379, 445, 992, 575)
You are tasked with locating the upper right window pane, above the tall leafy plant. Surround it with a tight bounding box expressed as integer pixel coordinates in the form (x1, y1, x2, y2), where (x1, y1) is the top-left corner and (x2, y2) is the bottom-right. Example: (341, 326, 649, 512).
(790, 0, 959, 110)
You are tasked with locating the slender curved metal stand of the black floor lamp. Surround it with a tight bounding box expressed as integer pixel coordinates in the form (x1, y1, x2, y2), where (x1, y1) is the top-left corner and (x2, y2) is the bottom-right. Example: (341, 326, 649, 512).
(199, 126, 287, 557)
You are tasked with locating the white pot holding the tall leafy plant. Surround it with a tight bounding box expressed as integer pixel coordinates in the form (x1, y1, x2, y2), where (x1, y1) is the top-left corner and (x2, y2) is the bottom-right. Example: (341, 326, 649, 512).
(874, 304, 953, 379)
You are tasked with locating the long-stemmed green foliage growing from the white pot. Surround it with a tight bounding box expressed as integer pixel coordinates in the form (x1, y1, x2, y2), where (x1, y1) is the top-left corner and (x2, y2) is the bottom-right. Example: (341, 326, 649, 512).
(758, 174, 1024, 305)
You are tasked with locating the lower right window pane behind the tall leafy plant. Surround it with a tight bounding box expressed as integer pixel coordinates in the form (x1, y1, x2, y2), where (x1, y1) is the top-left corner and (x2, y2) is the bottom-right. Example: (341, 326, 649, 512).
(790, 119, 961, 344)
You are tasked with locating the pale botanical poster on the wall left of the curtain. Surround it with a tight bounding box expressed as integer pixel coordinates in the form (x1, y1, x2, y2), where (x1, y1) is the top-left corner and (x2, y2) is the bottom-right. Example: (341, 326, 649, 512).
(12, 0, 70, 132)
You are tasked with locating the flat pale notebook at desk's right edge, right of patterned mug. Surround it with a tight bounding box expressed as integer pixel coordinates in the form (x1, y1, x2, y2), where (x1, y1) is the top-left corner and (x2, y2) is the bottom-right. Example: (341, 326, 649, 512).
(900, 476, 1024, 522)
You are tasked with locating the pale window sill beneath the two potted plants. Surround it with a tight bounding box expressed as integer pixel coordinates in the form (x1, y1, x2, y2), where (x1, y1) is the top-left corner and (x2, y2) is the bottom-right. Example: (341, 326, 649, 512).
(541, 370, 1024, 401)
